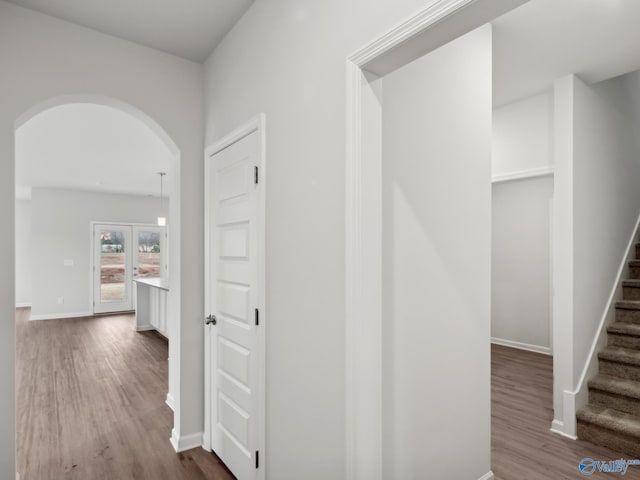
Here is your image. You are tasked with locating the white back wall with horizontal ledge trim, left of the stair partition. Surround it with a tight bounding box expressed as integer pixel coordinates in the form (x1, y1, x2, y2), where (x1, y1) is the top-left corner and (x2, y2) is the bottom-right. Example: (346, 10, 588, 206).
(491, 92, 554, 353)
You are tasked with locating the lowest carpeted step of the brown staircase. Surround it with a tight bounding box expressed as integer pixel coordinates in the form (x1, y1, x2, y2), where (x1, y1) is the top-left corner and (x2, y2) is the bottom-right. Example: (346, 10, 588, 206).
(577, 405, 640, 458)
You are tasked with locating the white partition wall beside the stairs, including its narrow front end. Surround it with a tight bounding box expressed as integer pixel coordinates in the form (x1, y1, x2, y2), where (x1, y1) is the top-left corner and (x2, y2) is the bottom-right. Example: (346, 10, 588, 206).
(553, 74, 640, 435)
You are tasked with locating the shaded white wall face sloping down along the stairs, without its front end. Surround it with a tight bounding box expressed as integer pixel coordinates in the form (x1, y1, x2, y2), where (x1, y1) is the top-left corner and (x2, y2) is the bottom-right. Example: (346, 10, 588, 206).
(573, 73, 640, 381)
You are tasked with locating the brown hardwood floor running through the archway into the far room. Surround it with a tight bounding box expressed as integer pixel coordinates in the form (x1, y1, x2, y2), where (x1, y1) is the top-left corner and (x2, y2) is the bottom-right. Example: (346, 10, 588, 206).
(16, 309, 234, 480)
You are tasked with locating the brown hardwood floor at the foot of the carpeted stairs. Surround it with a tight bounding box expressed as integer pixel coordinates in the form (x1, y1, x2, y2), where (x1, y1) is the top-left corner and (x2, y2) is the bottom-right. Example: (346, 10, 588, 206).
(491, 345, 640, 480)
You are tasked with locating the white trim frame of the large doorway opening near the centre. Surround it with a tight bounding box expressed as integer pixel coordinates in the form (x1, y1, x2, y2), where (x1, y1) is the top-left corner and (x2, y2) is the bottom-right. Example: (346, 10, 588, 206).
(345, 0, 529, 480)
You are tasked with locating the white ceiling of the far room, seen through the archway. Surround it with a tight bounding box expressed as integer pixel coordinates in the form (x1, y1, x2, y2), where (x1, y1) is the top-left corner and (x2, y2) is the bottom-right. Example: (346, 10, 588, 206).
(16, 104, 171, 198)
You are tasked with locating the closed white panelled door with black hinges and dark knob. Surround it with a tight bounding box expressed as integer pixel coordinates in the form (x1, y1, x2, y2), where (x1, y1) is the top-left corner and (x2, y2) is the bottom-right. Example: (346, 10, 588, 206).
(206, 125, 264, 480)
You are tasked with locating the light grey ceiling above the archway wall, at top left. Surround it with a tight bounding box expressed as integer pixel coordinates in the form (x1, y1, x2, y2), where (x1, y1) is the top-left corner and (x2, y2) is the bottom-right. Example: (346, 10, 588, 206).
(8, 0, 254, 63)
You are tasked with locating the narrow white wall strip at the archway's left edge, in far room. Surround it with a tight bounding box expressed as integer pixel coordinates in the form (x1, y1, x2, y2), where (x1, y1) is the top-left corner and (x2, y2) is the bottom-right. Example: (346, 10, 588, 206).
(16, 199, 32, 306)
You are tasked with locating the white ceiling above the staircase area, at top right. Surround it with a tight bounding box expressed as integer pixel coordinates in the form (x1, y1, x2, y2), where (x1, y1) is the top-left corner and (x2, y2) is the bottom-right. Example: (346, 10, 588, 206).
(492, 0, 640, 106)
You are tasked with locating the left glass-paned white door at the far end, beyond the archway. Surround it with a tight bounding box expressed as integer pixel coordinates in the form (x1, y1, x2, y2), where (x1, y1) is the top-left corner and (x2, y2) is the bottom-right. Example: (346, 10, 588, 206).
(93, 224, 133, 313)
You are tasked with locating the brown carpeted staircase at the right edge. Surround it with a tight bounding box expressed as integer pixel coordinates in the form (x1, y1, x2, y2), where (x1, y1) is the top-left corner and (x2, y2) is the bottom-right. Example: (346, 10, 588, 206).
(577, 243, 640, 459)
